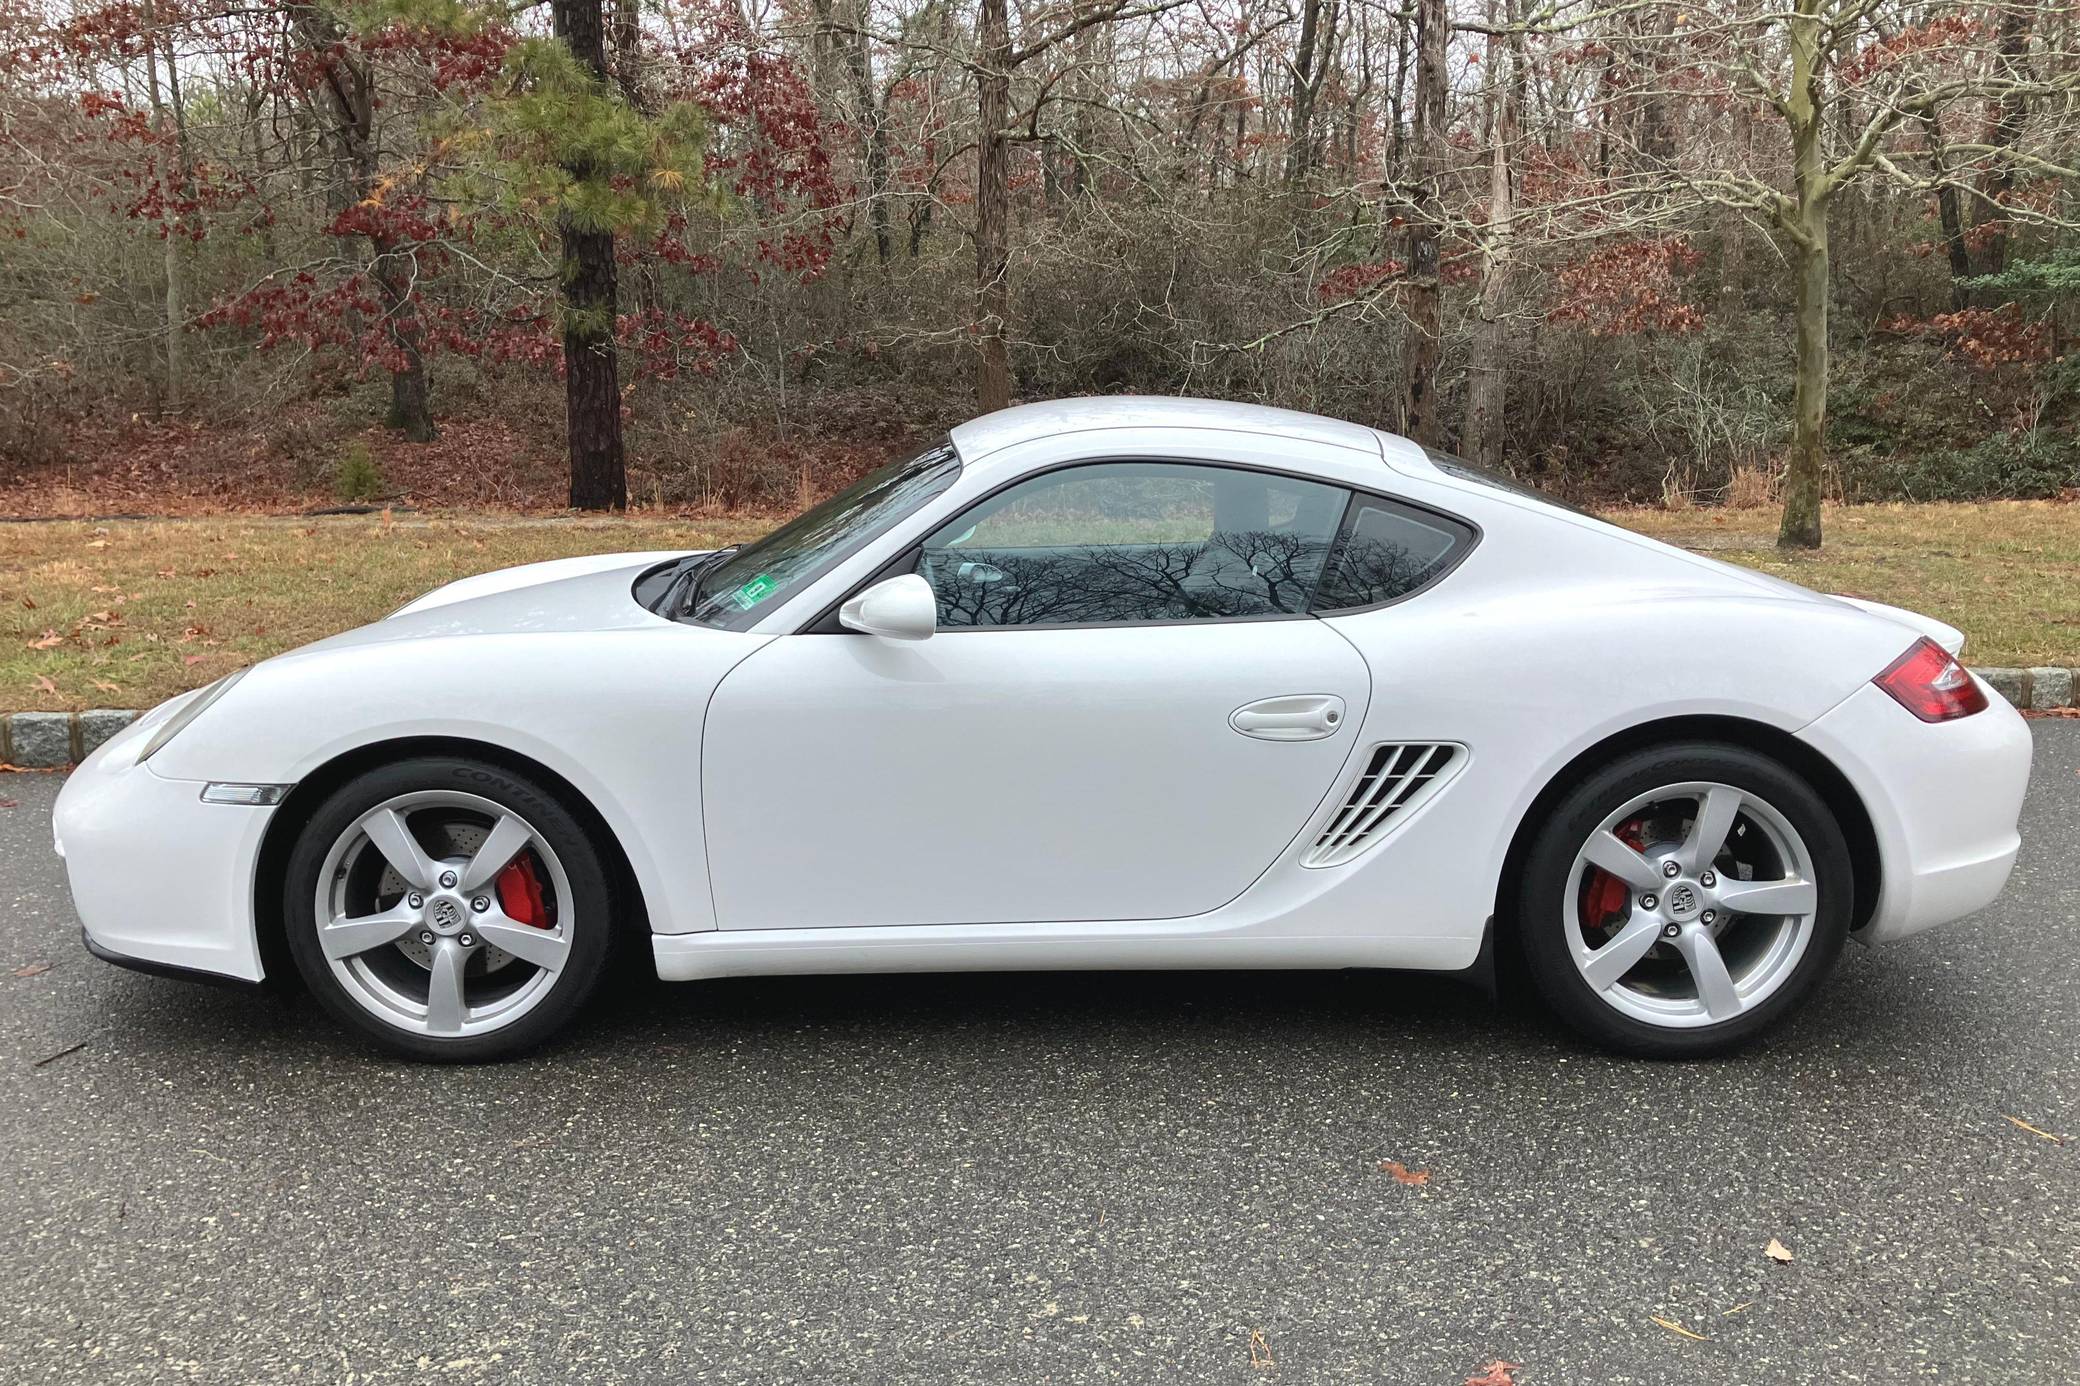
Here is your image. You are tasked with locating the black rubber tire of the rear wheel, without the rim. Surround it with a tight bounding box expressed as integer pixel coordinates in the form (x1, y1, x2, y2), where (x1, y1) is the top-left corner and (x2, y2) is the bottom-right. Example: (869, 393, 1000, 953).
(1514, 741, 1855, 1059)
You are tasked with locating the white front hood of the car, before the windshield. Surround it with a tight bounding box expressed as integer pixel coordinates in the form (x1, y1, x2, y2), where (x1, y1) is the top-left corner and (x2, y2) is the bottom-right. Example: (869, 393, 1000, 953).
(304, 551, 680, 649)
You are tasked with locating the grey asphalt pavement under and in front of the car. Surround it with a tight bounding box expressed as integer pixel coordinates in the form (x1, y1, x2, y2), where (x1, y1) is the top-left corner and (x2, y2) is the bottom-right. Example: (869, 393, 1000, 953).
(0, 722, 2080, 1386)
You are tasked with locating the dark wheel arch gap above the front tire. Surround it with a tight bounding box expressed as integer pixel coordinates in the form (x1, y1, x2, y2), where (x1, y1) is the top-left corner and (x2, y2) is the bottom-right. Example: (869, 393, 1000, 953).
(252, 737, 649, 989)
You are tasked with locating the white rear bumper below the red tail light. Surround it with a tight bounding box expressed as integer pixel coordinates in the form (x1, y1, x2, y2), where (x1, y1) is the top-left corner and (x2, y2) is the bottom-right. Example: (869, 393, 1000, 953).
(1799, 685, 2032, 943)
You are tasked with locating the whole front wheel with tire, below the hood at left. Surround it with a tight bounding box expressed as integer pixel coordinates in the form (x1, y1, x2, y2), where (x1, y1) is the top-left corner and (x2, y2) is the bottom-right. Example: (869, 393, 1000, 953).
(283, 758, 612, 1061)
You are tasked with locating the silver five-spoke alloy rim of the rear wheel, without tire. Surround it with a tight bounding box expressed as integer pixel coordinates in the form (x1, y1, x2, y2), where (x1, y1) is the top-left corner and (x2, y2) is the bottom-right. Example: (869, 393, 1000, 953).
(1564, 780, 1820, 1028)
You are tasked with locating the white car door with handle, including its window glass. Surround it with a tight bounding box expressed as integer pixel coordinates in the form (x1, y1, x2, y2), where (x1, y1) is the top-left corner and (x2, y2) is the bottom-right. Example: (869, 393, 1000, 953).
(703, 462, 1371, 928)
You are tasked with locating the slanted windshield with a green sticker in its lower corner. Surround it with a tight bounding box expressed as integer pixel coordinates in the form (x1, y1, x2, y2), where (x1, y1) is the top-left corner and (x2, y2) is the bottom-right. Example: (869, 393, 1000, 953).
(686, 439, 961, 631)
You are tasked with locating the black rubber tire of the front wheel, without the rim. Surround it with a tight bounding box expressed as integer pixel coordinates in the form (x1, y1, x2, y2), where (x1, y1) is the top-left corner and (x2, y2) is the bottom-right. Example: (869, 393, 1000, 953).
(283, 755, 616, 1063)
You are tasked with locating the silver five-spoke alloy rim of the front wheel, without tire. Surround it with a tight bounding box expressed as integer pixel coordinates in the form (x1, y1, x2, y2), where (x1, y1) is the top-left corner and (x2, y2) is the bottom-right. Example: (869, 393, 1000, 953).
(316, 789, 574, 1038)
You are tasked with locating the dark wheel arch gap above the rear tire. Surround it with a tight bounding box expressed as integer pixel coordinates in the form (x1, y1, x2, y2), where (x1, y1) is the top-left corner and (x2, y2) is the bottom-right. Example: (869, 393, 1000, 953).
(1491, 716, 1880, 961)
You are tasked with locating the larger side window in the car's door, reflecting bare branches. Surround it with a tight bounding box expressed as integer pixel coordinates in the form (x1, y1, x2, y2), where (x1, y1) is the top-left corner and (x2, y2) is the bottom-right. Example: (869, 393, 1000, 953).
(917, 462, 1350, 626)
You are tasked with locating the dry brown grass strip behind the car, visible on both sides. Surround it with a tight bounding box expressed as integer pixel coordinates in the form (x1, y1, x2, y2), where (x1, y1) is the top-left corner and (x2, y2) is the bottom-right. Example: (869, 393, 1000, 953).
(0, 502, 2080, 712)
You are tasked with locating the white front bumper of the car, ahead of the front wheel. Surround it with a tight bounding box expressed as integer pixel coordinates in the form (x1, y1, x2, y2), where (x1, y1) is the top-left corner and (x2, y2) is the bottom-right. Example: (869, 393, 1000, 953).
(52, 718, 272, 982)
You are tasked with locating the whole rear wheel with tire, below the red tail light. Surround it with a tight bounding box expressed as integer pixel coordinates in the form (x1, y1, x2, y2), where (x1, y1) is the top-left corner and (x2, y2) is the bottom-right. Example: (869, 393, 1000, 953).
(1516, 743, 1855, 1057)
